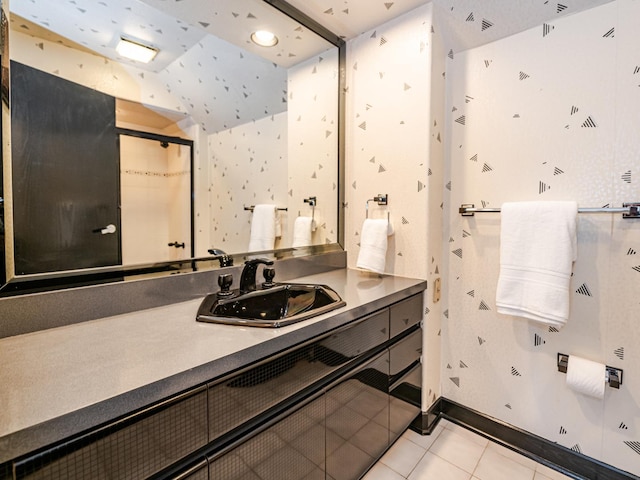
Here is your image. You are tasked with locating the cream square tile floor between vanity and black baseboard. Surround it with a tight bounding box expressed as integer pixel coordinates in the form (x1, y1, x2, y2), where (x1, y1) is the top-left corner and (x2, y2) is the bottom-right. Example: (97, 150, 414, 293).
(363, 420, 570, 480)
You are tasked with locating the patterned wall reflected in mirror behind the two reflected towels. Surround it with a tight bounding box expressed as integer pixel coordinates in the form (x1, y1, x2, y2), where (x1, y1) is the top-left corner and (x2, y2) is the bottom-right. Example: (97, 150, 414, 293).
(208, 49, 338, 253)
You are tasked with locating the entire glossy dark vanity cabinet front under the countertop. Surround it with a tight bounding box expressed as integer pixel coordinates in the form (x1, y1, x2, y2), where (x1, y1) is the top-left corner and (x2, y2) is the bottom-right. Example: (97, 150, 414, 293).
(7, 294, 422, 480)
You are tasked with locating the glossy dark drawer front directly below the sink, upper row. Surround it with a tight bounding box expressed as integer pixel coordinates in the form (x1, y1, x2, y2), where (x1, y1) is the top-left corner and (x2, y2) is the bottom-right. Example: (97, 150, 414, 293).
(209, 310, 389, 438)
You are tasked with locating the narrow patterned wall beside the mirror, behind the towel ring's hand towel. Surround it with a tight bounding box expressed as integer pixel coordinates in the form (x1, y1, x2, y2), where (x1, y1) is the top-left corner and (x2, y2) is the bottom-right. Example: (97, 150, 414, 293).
(345, 4, 444, 410)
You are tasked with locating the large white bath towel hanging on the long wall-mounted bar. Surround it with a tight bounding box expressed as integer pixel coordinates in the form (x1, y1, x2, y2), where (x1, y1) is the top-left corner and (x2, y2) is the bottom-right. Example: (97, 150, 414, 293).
(496, 202, 578, 326)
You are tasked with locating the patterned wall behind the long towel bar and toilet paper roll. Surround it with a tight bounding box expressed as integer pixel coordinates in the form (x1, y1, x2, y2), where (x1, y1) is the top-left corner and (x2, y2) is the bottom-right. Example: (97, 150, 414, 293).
(442, 0, 640, 475)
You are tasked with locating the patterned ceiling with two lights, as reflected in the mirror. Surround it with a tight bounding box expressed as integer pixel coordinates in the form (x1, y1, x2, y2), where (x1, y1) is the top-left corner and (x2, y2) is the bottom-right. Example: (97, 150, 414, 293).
(10, 0, 331, 73)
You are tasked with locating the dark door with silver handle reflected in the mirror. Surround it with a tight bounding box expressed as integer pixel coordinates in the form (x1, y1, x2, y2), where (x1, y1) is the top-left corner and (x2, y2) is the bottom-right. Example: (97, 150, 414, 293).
(11, 62, 121, 275)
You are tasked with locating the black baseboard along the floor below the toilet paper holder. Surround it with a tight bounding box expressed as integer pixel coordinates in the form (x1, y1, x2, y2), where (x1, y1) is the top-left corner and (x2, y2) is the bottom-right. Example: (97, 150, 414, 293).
(410, 397, 640, 480)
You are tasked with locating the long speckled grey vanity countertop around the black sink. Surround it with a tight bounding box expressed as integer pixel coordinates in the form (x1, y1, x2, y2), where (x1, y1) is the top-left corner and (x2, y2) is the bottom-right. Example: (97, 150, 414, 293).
(0, 269, 426, 463)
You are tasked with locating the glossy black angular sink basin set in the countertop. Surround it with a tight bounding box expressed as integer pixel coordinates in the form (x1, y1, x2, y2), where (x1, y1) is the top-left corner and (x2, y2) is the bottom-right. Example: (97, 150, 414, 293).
(196, 283, 346, 327)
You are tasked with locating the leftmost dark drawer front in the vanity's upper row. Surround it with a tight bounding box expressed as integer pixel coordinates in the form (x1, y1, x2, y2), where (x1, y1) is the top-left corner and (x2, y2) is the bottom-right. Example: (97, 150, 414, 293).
(15, 388, 207, 480)
